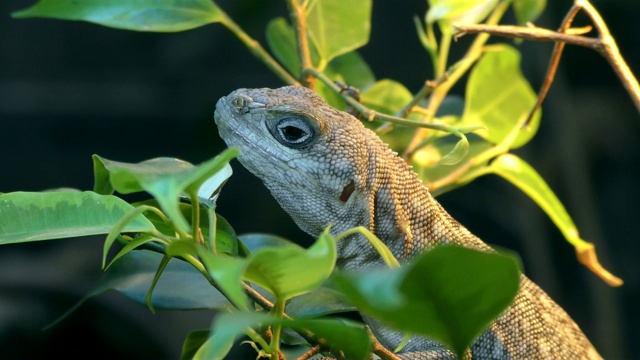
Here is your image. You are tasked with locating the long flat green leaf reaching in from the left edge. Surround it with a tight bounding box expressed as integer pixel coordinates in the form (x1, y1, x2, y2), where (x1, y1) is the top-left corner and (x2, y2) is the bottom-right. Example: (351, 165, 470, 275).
(0, 191, 153, 244)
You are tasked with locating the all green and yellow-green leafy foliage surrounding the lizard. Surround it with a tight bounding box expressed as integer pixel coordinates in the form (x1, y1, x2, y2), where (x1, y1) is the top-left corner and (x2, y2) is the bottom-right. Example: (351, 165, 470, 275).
(0, 0, 628, 359)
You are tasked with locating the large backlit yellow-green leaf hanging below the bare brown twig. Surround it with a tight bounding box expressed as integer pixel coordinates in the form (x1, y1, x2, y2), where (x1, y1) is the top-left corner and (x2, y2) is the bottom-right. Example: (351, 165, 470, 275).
(460, 45, 540, 149)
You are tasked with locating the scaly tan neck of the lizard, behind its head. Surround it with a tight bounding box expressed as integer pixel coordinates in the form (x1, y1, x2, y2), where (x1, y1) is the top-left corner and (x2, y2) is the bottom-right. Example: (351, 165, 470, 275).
(338, 146, 490, 269)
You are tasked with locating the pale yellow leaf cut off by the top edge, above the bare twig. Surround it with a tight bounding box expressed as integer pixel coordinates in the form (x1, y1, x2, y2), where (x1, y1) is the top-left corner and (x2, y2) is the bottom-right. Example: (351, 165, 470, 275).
(426, 0, 498, 32)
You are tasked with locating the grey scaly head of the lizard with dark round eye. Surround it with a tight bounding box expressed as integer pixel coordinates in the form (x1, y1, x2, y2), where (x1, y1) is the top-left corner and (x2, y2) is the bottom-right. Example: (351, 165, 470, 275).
(215, 86, 370, 236)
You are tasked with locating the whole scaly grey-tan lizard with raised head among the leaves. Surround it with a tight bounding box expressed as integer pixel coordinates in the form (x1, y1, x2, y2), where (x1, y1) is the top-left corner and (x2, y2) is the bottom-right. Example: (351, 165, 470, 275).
(214, 86, 601, 360)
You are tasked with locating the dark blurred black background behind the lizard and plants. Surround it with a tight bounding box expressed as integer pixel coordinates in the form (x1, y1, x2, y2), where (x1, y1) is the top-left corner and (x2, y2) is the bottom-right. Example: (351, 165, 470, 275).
(0, 0, 640, 359)
